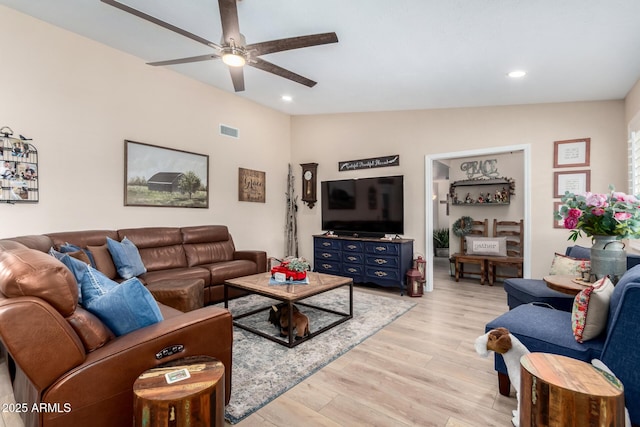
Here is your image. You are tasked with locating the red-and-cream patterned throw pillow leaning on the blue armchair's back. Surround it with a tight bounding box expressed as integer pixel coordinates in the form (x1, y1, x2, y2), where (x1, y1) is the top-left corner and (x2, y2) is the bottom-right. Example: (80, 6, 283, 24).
(571, 276, 613, 343)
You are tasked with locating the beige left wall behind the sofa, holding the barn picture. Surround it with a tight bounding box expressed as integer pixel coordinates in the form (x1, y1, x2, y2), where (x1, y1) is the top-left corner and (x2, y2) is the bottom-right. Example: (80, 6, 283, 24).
(0, 6, 290, 254)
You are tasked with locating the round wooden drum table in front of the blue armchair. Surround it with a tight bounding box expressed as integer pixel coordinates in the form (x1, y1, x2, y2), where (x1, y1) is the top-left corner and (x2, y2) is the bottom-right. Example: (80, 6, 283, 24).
(520, 353, 624, 427)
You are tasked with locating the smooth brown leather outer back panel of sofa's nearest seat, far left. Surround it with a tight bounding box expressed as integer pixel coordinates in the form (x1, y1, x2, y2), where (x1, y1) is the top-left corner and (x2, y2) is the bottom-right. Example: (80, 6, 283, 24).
(0, 297, 86, 390)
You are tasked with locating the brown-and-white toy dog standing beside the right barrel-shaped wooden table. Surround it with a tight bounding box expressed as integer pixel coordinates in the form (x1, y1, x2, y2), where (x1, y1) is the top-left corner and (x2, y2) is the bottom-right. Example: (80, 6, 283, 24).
(475, 328, 529, 427)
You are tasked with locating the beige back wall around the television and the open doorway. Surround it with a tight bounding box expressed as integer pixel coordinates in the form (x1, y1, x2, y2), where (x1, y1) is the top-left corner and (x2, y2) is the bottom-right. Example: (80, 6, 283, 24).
(291, 101, 627, 277)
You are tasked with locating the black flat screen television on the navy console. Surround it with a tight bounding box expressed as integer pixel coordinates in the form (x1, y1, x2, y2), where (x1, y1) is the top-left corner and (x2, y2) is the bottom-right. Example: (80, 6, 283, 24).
(321, 175, 404, 237)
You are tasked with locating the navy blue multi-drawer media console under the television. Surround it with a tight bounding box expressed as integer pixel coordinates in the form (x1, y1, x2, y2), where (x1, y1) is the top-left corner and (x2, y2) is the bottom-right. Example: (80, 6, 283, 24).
(313, 235, 413, 294)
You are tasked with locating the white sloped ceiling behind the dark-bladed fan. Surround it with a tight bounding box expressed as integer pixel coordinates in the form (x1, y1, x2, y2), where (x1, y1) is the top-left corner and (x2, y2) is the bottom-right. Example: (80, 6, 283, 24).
(0, 0, 640, 115)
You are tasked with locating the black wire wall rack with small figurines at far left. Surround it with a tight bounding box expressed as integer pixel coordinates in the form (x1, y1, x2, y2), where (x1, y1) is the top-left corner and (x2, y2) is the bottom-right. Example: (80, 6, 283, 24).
(0, 126, 39, 203)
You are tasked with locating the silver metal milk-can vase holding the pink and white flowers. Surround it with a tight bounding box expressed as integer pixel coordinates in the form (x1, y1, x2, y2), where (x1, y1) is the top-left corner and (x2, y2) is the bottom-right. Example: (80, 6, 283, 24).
(591, 236, 627, 284)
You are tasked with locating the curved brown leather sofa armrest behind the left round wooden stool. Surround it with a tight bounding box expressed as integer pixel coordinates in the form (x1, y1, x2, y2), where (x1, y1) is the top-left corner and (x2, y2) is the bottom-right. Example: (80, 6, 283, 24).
(44, 306, 233, 425)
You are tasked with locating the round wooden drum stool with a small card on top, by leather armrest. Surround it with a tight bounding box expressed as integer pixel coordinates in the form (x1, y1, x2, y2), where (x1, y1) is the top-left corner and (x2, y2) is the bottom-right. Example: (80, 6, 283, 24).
(133, 356, 224, 427)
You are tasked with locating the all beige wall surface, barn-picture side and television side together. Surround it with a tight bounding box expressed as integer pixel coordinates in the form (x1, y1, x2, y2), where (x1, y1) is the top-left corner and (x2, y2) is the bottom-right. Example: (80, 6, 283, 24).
(6, 6, 640, 282)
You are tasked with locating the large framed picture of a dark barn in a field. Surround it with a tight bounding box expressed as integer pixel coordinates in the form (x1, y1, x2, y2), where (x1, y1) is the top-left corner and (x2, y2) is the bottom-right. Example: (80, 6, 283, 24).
(124, 140, 209, 208)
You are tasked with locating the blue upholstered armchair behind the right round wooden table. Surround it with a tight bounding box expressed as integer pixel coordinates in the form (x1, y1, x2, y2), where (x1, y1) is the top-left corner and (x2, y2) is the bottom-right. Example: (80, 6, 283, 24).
(485, 265, 640, 425)
